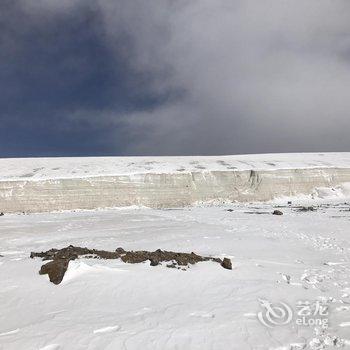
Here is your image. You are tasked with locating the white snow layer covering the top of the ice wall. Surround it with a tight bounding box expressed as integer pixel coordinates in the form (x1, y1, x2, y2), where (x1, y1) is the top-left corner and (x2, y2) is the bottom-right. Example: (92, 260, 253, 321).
(0, 153, 350, 181)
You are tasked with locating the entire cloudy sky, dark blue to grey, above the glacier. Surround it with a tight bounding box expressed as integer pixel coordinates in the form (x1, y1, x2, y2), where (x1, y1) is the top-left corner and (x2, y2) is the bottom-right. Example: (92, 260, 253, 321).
(0, 0, 350, 157)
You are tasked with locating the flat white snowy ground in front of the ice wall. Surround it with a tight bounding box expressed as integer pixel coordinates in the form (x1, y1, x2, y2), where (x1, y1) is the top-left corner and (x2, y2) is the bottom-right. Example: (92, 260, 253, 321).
(0, 201, 350, 350)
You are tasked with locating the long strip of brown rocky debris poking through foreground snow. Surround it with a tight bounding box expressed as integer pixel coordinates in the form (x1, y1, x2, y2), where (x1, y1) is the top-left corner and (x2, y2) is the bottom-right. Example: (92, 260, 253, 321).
(30, 245, 232, 284)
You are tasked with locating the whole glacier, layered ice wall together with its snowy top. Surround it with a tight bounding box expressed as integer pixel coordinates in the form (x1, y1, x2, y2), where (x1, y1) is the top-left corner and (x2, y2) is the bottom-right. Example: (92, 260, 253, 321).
(0, 153, 350, 212)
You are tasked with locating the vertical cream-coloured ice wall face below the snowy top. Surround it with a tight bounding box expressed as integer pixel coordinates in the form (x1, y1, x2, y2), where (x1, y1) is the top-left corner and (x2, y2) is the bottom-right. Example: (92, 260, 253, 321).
(0, 167, 350, 212)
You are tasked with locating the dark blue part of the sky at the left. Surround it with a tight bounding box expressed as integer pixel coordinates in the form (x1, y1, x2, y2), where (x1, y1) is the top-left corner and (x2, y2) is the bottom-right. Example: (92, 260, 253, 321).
(0, 1, 179, 156)
